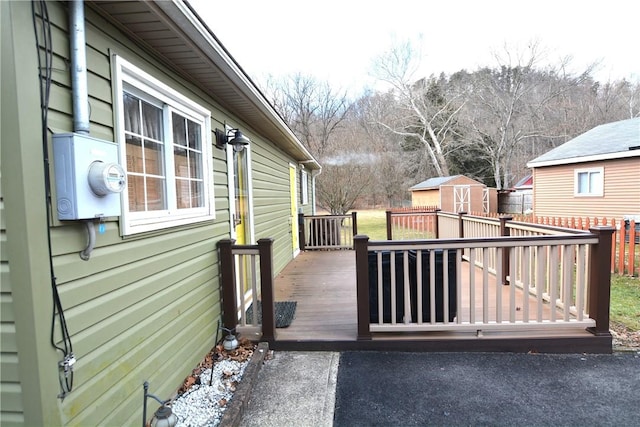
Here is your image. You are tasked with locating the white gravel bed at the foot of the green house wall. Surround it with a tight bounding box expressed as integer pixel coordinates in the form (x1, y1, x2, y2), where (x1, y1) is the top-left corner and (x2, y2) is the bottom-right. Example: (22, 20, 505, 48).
(171, 360, 248, 427)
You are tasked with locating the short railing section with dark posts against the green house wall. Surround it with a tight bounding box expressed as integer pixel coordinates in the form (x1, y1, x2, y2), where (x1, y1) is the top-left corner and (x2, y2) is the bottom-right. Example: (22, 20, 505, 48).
(218, 239, 276, 342)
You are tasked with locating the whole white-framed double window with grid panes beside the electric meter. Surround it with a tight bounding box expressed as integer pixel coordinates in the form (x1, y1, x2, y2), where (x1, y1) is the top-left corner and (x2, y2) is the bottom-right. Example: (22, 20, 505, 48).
(115, 57, 215, 234)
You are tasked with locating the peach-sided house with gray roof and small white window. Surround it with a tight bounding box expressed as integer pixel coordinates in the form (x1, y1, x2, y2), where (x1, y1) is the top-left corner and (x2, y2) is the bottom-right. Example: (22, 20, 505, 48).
(527, 118, 640, 218)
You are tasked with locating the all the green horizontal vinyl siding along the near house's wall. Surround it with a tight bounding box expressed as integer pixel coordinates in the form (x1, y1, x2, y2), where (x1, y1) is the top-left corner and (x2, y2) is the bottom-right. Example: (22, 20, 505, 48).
(0, 2, 311, 427)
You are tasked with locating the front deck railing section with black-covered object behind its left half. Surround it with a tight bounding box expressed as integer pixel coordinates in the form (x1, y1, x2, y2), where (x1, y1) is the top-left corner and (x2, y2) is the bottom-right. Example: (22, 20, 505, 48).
(355, 227, 614, 339)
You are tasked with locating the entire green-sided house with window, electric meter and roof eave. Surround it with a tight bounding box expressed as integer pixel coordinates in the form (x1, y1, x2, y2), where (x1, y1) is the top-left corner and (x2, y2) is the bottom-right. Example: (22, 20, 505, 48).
(0, 0, 320, 427)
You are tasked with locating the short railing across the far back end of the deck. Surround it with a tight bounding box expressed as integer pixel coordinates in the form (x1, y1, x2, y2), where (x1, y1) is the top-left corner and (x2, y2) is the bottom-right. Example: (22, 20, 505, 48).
(298, 212, 358, 250)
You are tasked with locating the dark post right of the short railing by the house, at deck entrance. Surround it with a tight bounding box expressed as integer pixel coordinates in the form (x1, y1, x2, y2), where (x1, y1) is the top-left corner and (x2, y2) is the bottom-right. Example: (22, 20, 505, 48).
(258, 239, 276, 343)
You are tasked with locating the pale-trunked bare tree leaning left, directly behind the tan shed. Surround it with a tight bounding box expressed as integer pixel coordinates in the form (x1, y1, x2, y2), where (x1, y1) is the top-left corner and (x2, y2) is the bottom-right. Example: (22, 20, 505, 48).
(374, 42, 463, 176)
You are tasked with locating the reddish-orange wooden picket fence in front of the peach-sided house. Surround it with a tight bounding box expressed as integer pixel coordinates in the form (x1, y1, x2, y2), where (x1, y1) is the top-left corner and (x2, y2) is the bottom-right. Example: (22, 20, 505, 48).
(470, 213, 640, 277)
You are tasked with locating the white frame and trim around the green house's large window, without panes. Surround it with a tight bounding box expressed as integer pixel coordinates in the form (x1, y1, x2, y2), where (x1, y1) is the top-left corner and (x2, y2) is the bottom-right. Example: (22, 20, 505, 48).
(113, 55, 215, 235)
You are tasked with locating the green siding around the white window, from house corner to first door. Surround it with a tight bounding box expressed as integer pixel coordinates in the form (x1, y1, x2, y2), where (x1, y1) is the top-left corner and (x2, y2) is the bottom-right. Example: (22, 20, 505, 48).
(52, 7, 229, 425)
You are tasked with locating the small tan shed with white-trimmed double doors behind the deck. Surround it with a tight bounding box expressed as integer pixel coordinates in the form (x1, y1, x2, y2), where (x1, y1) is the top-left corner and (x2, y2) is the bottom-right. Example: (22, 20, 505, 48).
(409, 175, 498, 213)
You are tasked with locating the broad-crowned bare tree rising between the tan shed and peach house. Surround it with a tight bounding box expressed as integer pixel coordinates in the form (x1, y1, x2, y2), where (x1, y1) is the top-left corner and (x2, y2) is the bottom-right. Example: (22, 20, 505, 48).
(464, 42, 591, 189)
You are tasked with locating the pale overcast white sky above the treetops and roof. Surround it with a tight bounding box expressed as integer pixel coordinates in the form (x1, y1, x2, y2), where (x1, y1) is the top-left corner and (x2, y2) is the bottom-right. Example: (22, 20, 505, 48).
(189, 0, 640, 91)
